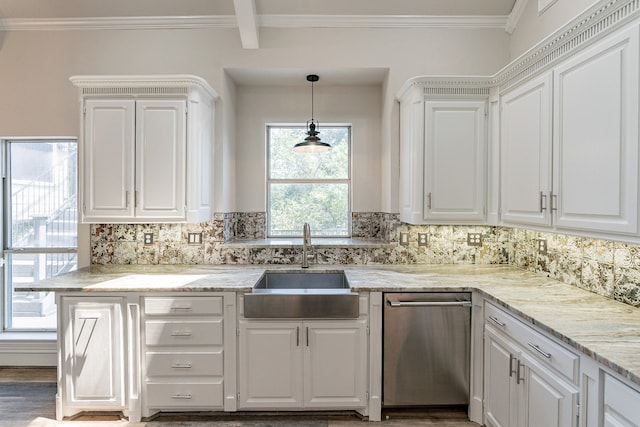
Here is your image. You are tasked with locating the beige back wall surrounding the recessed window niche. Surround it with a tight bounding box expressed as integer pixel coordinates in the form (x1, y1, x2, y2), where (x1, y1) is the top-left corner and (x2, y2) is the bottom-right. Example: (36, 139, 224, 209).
(0, 23, 509, 212)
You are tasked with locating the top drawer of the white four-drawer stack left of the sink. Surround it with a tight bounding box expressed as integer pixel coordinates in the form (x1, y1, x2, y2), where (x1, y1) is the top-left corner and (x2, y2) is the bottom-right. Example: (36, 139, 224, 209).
(144, 297, 222, 316)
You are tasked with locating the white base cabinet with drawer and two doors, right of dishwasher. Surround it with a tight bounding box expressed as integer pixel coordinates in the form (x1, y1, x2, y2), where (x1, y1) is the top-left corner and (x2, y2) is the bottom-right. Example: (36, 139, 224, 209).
(485, 304, 579, 427)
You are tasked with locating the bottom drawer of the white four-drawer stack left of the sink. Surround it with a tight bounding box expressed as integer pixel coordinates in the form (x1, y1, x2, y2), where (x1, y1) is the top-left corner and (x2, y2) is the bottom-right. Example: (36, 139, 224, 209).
(147, 381, 222, 409)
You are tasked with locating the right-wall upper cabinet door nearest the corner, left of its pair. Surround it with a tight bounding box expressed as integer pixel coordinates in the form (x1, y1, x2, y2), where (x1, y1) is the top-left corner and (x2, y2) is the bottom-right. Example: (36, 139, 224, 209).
(500, 74, 552, 226)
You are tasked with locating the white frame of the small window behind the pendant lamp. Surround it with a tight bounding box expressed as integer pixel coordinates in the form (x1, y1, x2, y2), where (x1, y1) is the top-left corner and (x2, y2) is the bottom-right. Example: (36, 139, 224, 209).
(265, 123, 353, 239)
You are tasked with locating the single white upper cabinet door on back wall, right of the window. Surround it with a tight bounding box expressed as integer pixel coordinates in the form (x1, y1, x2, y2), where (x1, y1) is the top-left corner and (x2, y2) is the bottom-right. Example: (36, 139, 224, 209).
(424, 101, 486, 222)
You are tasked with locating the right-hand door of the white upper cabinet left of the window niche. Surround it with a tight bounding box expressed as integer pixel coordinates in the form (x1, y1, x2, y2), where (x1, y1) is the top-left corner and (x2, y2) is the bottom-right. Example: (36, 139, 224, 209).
(135, 99, 186, 220)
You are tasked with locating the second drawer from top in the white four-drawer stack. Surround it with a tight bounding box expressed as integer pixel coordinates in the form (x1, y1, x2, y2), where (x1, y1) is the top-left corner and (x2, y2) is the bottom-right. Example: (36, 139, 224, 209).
(145, 319, 222, 346)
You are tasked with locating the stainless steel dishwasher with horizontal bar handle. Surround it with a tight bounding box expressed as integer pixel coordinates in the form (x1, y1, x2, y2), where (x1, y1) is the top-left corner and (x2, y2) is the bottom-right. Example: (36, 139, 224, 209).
(382, 292, 471, 407)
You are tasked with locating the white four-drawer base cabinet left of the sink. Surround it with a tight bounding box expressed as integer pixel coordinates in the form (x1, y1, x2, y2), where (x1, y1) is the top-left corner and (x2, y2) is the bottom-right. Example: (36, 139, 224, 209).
(142, 296, 224, 417)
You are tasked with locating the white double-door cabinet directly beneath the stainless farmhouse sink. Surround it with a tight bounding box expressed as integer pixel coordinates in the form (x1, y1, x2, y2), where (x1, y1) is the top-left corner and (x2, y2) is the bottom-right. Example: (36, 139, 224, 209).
(238, 320, 368, 410)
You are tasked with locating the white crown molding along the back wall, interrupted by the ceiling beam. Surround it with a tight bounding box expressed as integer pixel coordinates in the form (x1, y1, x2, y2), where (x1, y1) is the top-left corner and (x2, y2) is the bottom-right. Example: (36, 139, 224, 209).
(1, 15, 508, 31)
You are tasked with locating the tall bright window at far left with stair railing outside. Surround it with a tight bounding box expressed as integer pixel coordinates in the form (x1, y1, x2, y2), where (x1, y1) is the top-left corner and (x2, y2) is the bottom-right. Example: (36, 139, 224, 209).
(0, 139, 78, 331)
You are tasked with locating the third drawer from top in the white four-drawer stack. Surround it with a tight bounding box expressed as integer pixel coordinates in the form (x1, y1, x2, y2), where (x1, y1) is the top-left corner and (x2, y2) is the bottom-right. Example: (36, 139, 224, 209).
(146, 351, 223, 377)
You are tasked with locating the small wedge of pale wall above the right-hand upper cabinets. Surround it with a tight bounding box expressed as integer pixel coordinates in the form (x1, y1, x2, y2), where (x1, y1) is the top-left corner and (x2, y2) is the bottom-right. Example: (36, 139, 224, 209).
(511, 0, 598, 59)
